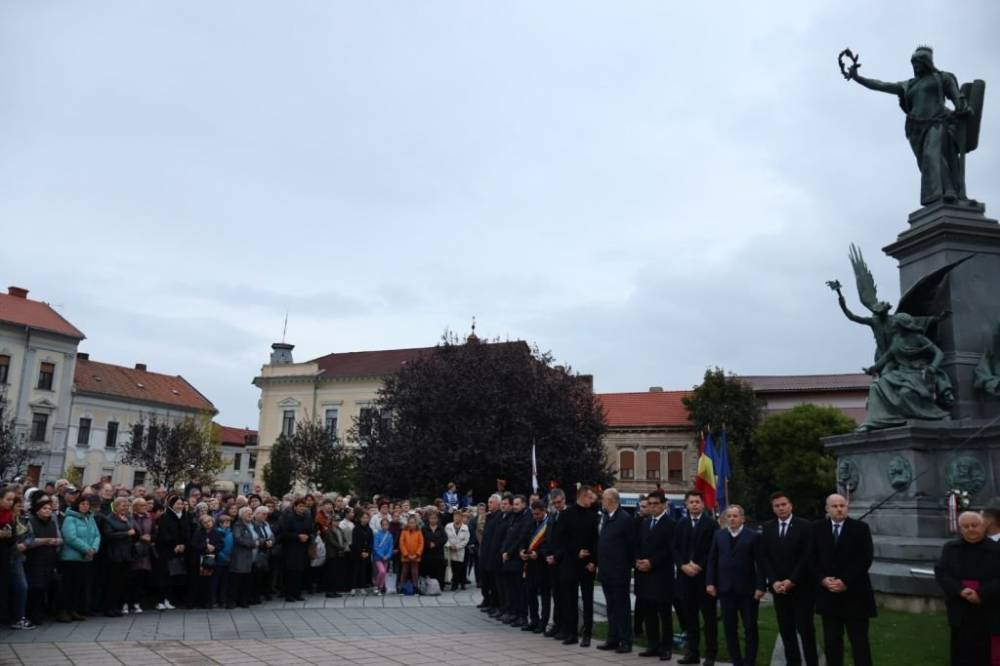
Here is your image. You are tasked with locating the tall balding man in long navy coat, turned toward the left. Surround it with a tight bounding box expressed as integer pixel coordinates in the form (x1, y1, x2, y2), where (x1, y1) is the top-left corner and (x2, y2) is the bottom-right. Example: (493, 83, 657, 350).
(597, 488, 635, 654)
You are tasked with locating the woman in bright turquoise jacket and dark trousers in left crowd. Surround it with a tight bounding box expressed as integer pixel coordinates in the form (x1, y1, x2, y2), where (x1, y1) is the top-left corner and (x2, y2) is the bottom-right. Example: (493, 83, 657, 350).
(59, 495, 101, 622)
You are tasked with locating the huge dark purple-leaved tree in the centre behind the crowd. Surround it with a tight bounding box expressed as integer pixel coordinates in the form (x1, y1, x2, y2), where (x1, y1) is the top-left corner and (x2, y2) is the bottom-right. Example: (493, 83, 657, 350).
(349, 335, 613, 498)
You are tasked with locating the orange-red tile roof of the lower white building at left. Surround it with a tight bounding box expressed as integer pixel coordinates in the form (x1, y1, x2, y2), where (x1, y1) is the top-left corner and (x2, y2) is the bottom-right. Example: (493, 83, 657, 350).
(73, 358, 216, 413)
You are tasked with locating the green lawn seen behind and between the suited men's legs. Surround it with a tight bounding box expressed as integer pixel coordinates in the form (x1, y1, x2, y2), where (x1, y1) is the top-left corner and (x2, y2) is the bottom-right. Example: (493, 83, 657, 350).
(594, 605, 950, 666)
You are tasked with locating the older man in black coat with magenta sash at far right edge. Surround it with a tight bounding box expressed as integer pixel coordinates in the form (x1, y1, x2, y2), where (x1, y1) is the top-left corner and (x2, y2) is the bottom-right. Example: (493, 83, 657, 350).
(934, 511, 1000, 666)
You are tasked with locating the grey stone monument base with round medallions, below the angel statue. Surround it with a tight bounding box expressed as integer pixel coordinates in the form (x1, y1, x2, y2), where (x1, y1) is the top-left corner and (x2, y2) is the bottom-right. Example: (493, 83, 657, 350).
(823, 419, 1000, 607)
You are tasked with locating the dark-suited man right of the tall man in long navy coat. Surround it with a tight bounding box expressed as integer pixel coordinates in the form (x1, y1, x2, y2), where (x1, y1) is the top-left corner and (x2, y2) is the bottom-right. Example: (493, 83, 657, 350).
(635, 490, 674, 661)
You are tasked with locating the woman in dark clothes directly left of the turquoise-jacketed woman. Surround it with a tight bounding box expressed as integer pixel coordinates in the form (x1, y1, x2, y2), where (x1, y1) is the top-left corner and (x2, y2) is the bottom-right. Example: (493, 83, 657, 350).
(24, 495, 62, 625)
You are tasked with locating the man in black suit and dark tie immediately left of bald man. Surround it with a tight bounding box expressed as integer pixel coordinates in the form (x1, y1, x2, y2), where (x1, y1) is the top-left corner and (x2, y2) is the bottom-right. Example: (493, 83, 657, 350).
(760, 491, 819, 666)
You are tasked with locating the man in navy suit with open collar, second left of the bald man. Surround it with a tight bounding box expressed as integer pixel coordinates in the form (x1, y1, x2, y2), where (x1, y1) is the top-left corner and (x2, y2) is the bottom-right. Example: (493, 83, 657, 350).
(705, 504, 767, 666)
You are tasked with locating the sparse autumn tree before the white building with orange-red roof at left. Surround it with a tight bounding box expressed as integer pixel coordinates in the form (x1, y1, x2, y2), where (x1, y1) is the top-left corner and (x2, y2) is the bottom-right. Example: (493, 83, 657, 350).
(119, 414, 225, 488)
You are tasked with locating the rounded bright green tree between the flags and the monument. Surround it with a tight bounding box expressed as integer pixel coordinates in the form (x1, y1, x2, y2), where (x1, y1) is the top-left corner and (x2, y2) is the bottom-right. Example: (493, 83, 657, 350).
(753, 404, 857, 518)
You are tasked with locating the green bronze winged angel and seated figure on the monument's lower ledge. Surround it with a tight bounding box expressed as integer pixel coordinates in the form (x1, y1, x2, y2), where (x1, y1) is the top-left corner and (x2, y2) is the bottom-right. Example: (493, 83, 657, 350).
(827, 244, 955, 430)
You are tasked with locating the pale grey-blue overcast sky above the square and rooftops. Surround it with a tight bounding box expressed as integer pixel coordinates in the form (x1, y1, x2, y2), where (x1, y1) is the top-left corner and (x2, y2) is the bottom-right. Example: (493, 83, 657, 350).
(0, 0, 1000, 427)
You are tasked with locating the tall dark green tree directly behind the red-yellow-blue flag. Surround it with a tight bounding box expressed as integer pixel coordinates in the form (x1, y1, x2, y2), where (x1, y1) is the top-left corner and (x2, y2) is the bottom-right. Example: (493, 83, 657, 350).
(683, 368, 770, 510)
